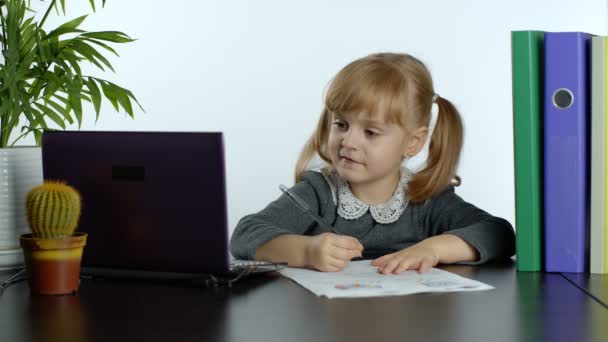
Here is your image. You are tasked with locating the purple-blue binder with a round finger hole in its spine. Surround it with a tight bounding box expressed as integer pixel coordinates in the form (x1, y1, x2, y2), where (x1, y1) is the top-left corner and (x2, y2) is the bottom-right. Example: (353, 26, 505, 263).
(544, 32, 590, 272)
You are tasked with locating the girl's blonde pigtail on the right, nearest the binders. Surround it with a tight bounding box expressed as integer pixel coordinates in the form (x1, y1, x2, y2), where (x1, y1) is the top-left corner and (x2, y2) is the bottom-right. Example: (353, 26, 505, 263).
(407, 97, 464, 202)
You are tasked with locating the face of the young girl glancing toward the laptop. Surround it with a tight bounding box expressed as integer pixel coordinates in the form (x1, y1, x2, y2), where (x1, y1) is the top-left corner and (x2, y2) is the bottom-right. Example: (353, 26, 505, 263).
(328, 113, 409, 192)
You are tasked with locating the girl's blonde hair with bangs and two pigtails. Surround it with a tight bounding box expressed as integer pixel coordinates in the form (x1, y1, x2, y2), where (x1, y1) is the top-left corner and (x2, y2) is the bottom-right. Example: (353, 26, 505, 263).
(295, 53, 463, 202)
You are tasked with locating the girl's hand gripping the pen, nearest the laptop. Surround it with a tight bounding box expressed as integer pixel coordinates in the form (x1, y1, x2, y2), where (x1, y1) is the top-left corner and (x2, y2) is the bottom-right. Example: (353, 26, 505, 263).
(306, 233, 363, 272)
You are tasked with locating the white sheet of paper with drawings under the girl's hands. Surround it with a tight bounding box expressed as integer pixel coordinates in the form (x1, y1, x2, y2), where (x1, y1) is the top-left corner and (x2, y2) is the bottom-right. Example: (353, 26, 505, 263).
(280, 260, 494, 298)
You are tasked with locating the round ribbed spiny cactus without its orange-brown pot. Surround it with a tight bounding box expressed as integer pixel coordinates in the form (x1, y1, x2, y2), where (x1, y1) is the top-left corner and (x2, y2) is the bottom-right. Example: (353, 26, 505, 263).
(26, 181, 80, 239)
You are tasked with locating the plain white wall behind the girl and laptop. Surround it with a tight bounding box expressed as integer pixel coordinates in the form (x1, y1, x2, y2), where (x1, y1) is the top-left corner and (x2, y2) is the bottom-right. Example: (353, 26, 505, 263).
(26, 0, 608, 235)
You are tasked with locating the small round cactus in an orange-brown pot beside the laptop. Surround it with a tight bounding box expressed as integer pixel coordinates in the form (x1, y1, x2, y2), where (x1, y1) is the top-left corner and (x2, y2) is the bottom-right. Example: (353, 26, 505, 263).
(19, 181, 87, 295)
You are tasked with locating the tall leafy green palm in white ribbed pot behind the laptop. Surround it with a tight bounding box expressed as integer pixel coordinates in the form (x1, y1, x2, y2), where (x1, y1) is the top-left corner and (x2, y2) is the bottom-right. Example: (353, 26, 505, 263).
(0, 0, 141, 269)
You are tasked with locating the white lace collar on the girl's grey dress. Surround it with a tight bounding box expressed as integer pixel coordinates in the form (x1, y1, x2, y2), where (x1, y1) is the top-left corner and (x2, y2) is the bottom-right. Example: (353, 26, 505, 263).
(317, 166, 411, 224)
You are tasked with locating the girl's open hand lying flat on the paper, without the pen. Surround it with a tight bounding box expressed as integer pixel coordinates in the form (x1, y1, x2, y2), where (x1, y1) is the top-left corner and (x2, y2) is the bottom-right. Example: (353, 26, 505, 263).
(372, 241, 439, 274)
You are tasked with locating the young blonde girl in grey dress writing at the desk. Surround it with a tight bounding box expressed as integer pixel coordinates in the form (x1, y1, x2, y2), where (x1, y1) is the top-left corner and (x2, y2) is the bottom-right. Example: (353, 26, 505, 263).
(230, 53, 515, 274)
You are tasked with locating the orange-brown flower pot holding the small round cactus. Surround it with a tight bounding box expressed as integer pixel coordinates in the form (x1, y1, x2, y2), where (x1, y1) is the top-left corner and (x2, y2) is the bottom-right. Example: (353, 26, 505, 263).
(19, 232, 87, 295)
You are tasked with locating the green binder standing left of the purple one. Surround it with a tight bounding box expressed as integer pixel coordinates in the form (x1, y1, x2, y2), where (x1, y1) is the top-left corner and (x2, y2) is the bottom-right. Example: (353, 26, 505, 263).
(511, 31, 544, 271)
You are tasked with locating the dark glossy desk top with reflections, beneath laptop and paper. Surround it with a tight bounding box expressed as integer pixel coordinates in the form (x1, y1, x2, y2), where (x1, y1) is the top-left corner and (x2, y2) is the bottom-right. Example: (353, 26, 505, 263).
(0, 263, 608, 342)
